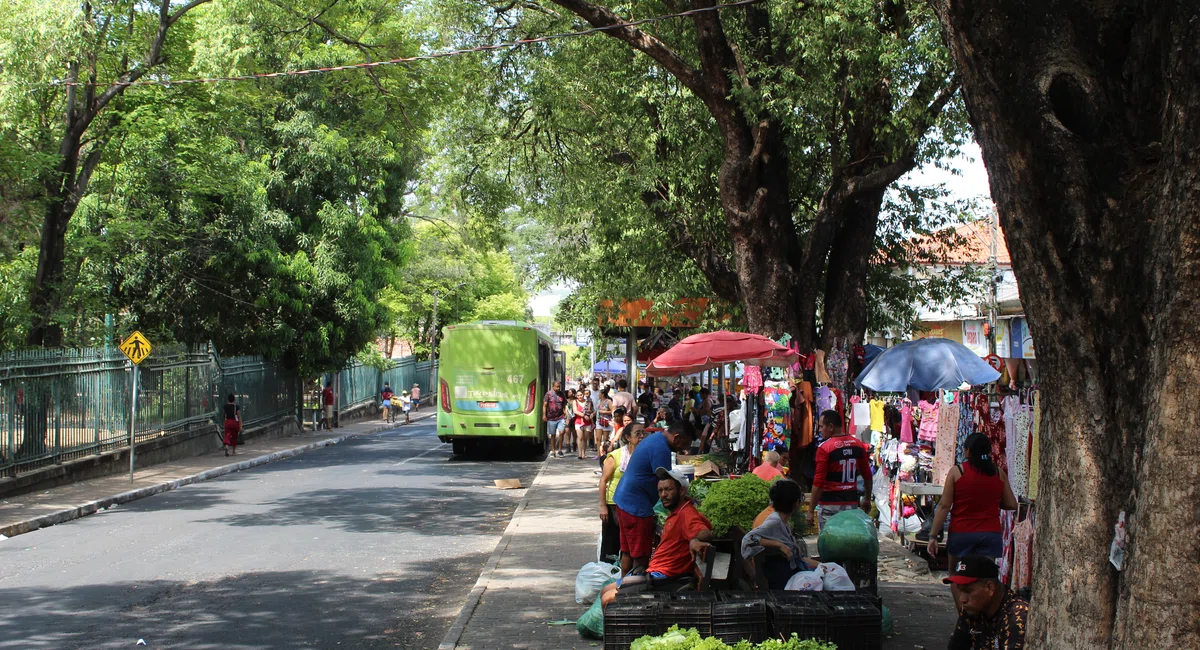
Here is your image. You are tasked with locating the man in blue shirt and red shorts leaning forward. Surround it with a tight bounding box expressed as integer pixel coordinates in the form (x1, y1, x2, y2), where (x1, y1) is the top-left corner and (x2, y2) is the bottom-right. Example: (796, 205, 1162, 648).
(612, 420, 696, 576)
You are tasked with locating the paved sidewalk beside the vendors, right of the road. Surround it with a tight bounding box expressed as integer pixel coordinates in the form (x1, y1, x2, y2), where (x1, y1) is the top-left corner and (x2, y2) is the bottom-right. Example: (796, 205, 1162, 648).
(439, 458, 956, 650)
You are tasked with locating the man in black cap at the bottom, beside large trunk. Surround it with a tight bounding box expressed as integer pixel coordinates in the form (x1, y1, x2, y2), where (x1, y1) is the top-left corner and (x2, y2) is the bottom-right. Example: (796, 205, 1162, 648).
(942, 555, 1030, 650)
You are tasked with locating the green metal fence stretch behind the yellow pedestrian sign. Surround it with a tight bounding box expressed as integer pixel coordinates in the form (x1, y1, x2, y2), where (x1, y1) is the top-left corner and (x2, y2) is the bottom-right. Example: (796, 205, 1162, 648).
(0, 345, 300, 476)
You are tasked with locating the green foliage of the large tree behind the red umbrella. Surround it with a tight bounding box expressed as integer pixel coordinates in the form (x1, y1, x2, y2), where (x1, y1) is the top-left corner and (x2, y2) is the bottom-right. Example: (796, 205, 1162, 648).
(431, 0, 978, 330)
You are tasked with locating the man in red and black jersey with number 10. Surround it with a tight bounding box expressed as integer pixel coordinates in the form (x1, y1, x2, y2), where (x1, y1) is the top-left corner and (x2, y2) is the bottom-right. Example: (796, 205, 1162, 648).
(809, 410, 871, 529)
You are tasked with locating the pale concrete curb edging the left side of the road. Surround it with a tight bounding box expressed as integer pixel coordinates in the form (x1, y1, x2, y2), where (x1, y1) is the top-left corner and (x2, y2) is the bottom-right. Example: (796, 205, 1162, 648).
(0, 421, 429, 537)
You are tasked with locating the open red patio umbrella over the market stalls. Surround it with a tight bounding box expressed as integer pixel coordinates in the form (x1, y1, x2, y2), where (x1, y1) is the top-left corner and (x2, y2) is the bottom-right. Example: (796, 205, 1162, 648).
(646, 331, 799, 377)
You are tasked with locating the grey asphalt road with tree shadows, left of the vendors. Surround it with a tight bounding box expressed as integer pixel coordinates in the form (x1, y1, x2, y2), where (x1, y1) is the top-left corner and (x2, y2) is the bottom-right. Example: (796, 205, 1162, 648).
(0, 423, 539, 649)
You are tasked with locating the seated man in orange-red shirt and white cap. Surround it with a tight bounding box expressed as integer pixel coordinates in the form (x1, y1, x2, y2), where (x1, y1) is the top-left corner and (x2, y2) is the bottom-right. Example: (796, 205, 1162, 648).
(600, 468, 713, 607)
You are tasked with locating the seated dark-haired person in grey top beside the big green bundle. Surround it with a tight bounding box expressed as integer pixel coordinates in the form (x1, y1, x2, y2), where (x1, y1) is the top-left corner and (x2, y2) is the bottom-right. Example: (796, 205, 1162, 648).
(742, 479, 816, 589)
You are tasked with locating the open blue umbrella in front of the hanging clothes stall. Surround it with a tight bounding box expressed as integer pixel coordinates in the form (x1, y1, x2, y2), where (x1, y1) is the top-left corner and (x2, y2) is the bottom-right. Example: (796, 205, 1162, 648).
(854, 338, 1000, 392)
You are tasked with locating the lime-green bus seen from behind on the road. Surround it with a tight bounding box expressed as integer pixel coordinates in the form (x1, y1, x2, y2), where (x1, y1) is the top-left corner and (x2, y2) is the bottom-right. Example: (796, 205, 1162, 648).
(438, 320, 566, 455)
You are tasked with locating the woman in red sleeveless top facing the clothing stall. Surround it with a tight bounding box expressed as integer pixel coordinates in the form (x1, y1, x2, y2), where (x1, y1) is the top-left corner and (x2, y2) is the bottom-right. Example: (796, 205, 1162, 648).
(929, 433, 1016, 566)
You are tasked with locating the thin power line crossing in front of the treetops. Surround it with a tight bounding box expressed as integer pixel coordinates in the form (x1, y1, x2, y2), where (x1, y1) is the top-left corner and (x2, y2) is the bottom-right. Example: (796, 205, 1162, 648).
(52, 0, 767, 88)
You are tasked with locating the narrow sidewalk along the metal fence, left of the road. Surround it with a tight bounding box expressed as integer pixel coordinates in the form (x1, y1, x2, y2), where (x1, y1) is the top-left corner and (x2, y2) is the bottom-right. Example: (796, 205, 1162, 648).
(0, 411, 433, 537)
